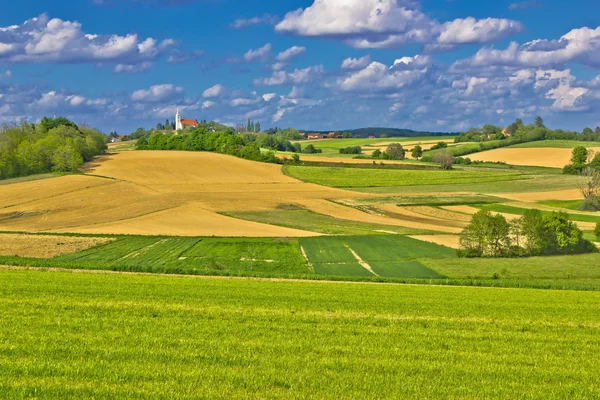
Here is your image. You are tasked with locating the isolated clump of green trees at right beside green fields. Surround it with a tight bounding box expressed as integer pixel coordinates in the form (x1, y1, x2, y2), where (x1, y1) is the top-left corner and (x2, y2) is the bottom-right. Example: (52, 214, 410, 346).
(458, 210, 598, 257)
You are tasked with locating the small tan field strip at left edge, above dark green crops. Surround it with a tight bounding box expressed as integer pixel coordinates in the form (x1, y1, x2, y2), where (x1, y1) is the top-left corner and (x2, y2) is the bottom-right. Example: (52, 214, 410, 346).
(0, 233, 114, 258)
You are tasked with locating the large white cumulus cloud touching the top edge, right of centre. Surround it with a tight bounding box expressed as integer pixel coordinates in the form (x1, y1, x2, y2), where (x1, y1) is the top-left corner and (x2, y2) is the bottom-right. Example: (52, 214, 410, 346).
(275, 0, 522, 51)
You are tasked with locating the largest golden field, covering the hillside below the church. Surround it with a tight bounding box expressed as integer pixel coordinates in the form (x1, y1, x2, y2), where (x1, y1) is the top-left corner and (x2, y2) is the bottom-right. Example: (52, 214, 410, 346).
(0, 151, 364, 237)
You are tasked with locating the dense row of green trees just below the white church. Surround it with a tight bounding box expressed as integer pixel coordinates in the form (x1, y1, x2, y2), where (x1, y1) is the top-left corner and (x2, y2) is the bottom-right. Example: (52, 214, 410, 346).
(137, 128, 292, 163)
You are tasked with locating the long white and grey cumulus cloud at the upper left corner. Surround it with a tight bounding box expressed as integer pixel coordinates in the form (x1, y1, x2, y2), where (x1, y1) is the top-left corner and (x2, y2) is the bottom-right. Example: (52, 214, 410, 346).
(0, 14, 174, 65)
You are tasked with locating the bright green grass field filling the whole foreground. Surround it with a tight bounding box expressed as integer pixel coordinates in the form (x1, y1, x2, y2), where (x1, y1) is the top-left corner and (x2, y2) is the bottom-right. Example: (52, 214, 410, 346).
(0, 271, 600, 399)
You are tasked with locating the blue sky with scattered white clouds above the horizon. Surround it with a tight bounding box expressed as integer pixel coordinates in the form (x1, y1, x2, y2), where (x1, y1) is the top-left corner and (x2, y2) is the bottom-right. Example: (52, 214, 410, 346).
(0, 0, 600, 133)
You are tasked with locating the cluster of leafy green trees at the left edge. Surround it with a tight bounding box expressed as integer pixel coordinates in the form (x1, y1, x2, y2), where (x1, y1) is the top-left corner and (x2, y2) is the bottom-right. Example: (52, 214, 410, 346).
(0, 117, 107, 179)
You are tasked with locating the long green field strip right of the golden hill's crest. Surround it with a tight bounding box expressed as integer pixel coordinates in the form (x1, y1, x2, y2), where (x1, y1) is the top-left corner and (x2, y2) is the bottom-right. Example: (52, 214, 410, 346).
(284, 165, 523, 188)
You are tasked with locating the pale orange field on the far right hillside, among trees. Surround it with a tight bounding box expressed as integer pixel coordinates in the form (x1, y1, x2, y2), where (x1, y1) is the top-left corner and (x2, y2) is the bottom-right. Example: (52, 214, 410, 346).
(469, 147, 600, 168)
